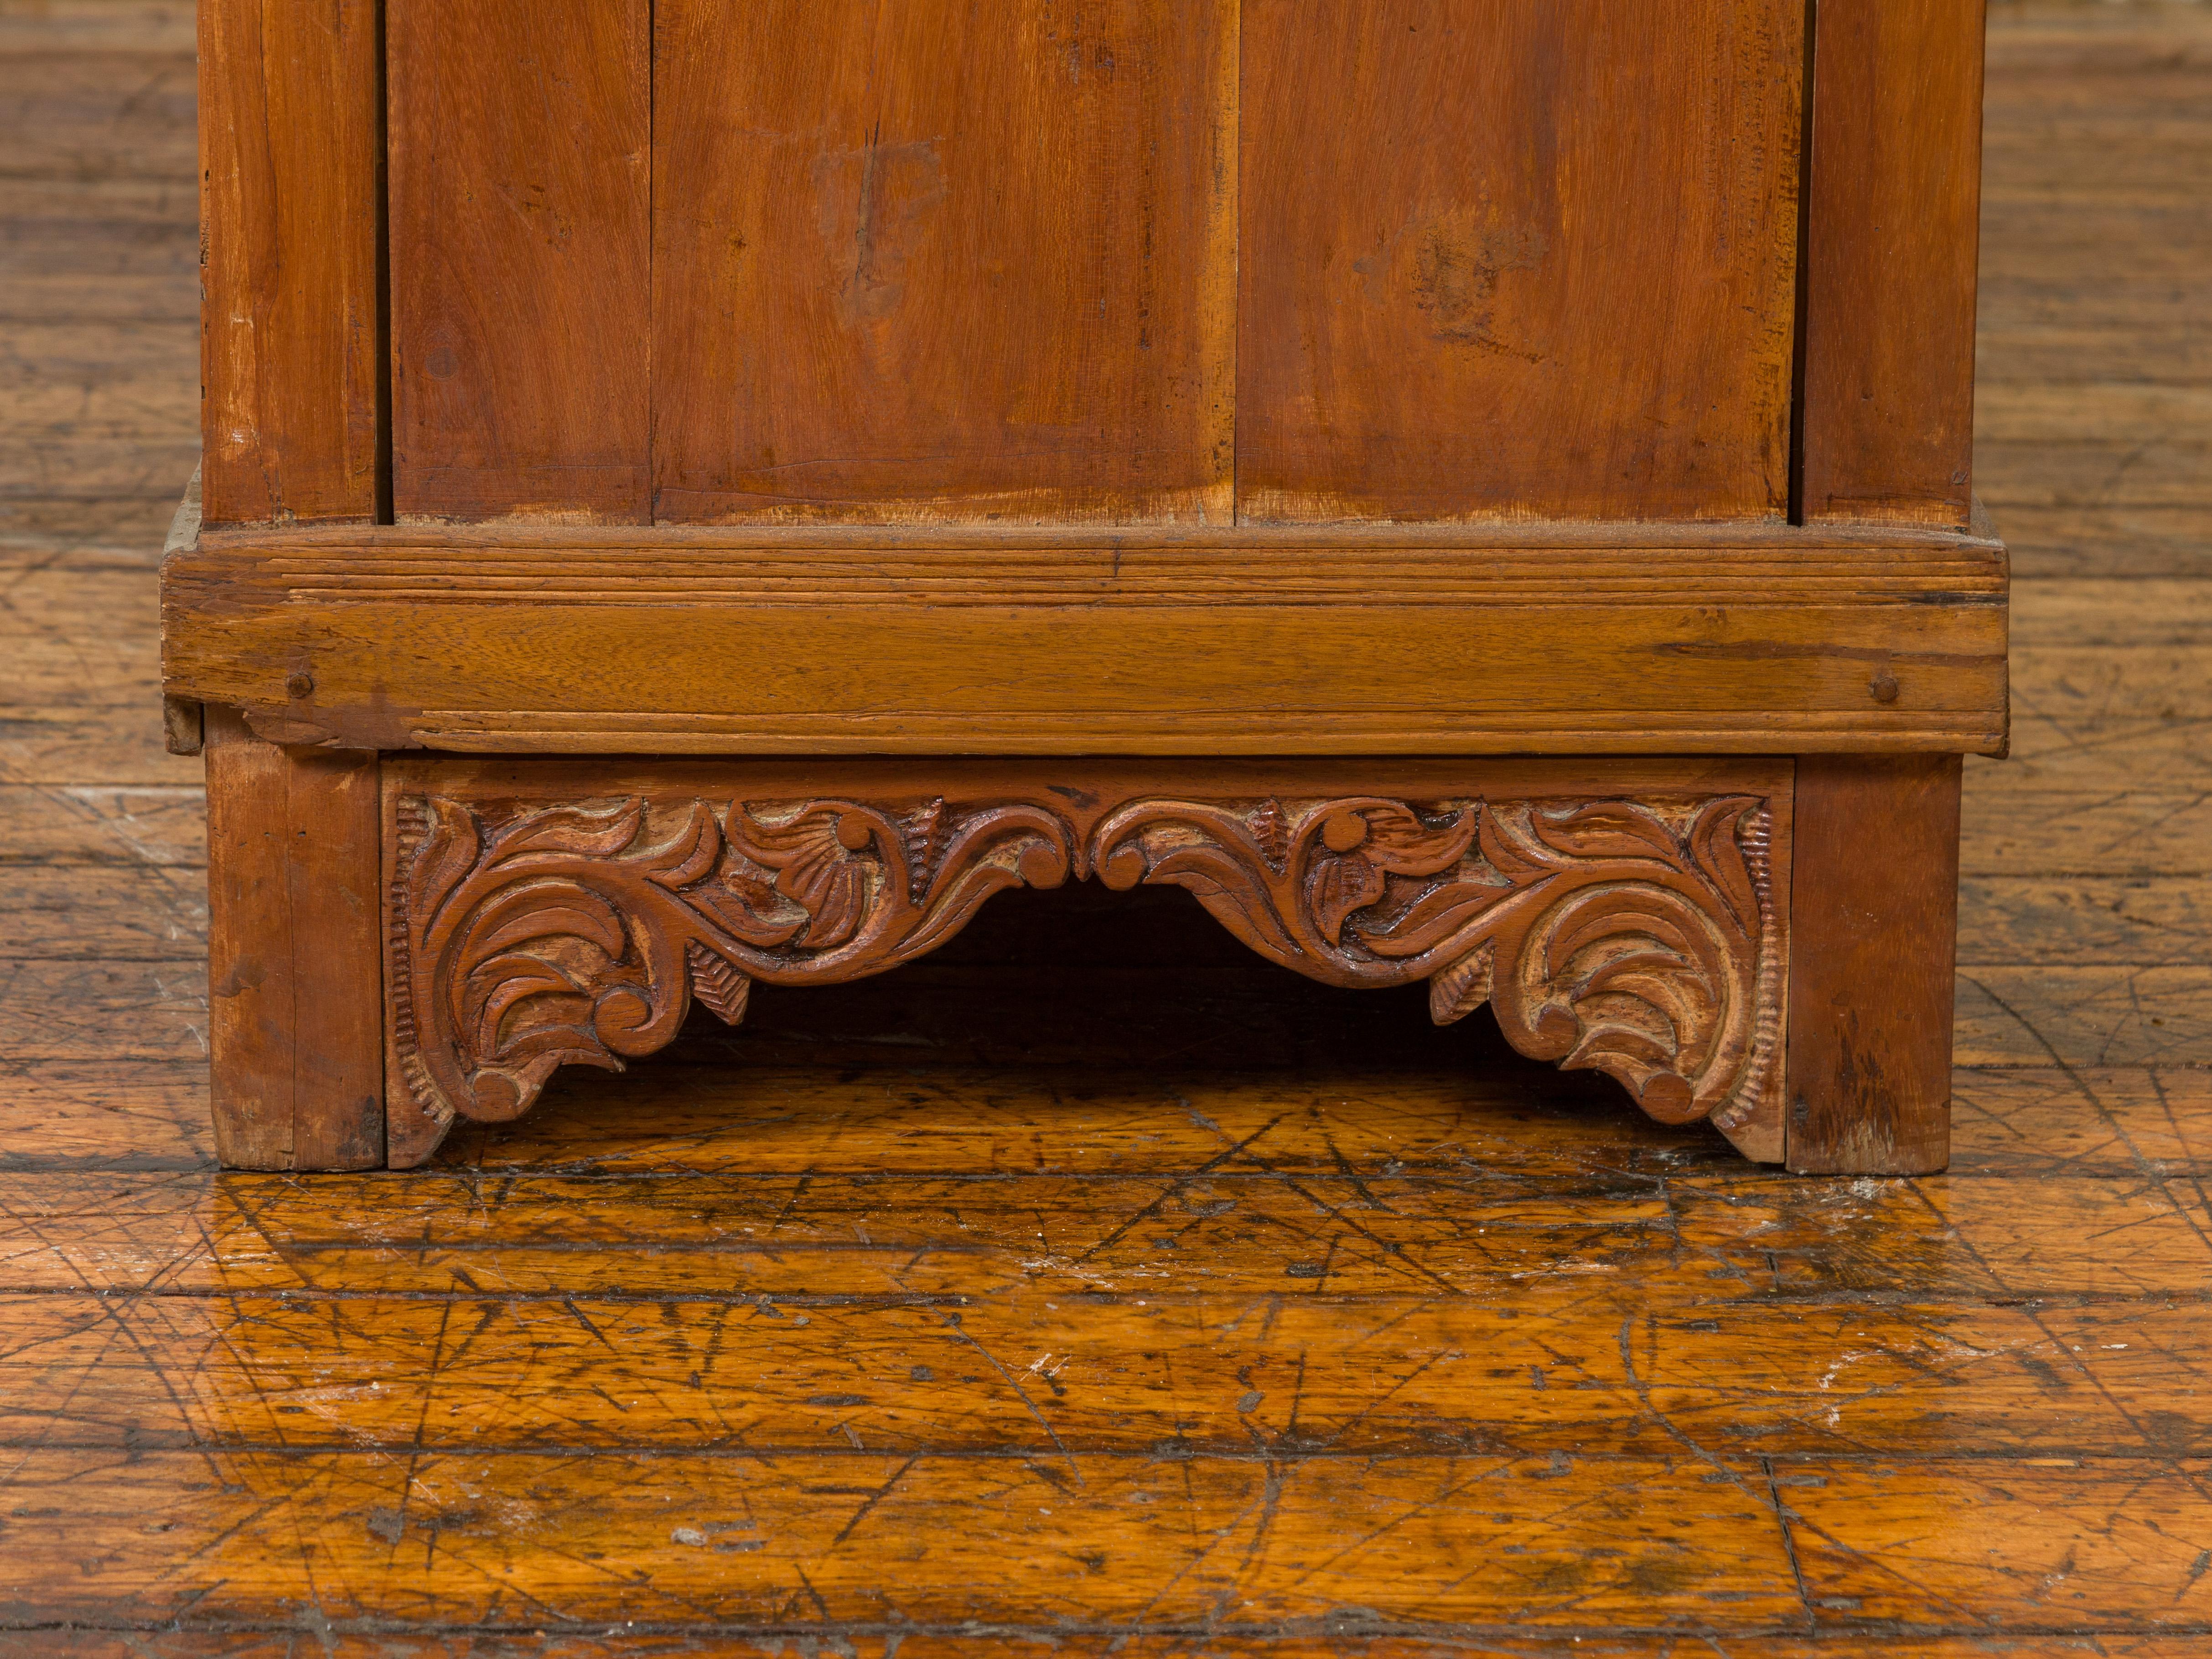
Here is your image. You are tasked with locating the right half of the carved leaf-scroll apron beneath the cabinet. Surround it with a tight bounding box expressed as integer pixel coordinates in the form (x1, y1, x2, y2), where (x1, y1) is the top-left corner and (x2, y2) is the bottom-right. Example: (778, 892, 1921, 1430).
(1097, 796, 1772, 1121)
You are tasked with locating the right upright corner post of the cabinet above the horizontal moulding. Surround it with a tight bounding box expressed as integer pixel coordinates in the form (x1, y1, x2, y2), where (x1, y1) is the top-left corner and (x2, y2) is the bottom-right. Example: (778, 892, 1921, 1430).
(1801, 0, 1982, 524)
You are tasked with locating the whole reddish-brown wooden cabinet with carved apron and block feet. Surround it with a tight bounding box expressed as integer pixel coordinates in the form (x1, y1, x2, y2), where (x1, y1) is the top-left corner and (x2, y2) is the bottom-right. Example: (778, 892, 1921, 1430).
(164, 0, 2006, 1170)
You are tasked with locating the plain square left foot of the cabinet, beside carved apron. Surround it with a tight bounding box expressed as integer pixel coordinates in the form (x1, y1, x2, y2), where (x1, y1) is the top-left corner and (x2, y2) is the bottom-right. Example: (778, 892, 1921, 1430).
(208, 708, 385, 1170)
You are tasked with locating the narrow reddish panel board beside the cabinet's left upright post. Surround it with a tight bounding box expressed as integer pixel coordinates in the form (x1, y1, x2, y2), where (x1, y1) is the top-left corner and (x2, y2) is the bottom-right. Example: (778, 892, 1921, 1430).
(389, 0, 653, 524)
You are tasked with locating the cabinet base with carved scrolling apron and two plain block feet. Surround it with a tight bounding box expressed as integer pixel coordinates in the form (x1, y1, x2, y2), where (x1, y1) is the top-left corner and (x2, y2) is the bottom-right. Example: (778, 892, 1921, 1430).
(208, 734, 1958, 1172)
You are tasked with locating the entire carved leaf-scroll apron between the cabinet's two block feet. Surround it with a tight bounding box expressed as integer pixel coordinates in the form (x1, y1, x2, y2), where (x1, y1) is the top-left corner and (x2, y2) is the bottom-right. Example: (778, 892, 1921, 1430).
(387, 785, 1783, 1166)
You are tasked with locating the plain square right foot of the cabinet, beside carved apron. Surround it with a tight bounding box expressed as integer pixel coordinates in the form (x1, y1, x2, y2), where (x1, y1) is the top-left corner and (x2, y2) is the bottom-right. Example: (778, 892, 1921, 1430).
(1787, 754, 1960, 1175)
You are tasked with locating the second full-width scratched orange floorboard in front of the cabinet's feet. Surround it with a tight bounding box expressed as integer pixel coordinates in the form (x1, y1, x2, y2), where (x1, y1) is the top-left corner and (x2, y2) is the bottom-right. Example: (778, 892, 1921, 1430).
(0, 1291, 2212, 1467)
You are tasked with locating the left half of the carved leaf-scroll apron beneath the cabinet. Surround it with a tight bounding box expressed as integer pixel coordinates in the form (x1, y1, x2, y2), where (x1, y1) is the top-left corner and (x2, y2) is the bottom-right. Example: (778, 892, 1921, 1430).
(392, 796, 1073, 1157)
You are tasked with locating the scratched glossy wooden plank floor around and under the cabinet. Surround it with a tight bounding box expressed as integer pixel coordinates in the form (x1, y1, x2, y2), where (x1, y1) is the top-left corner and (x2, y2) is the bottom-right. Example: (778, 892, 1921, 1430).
(0, 0, 2212, 1659)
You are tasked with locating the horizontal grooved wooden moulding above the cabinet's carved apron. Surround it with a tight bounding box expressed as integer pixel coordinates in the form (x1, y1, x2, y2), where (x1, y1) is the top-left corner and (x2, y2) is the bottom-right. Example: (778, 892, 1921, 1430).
(166, 524, 2006, 754)
